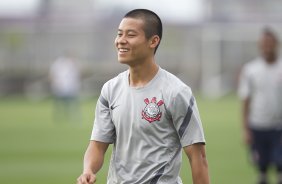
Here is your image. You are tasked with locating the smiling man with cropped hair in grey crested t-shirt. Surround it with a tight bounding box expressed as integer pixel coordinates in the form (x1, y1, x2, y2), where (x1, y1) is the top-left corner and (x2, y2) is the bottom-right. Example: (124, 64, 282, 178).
(77, 9, 209, 184)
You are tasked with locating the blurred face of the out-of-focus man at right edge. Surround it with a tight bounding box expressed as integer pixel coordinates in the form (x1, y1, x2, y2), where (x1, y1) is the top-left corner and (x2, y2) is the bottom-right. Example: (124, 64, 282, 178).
(260, 35, 277, 61)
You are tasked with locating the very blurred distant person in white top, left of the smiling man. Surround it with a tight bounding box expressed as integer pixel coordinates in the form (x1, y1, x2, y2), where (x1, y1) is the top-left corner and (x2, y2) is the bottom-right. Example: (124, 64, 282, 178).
(49, 51, 80, 121)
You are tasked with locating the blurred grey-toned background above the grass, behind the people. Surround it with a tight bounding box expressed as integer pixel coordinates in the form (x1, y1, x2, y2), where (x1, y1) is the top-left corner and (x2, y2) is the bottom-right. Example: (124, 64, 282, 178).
(0, 0, 282, 98)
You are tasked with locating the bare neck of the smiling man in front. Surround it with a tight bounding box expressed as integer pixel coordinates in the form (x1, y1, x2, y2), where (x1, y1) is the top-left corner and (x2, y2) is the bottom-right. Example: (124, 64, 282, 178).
(129, 60, 159, 87)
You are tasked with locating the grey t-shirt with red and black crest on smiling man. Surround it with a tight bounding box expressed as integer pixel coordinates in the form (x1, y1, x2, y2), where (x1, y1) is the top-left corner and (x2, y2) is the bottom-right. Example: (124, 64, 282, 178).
(91, 68, 205, 184)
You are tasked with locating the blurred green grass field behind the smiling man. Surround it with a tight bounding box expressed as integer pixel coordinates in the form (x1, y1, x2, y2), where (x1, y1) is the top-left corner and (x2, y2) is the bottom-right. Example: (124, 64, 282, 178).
(0, 95, 266, 184)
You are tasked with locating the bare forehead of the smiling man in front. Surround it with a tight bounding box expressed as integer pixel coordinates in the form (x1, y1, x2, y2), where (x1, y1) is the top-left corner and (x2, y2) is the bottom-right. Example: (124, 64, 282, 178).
(118, 18, 144, 32)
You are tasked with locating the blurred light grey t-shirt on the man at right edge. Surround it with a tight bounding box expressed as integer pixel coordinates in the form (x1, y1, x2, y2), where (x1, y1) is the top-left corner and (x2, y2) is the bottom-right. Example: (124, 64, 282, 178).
(238, 58, 282, 130)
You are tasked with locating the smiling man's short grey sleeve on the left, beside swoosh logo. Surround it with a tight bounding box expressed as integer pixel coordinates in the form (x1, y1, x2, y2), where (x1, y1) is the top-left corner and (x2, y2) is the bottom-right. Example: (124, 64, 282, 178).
(91, 85, 115, 143)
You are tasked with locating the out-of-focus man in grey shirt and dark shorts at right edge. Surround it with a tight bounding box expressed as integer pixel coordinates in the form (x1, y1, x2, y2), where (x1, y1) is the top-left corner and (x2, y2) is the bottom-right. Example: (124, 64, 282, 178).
(238, 28, 282, 184)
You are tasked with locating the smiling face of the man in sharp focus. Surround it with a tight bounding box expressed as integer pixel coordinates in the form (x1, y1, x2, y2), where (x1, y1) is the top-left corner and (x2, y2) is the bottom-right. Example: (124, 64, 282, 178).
(115, 18, 154, 66)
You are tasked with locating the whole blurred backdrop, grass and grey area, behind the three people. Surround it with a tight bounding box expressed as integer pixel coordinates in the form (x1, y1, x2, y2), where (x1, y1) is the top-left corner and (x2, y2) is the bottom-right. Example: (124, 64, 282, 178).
(0, 0, 282, 184)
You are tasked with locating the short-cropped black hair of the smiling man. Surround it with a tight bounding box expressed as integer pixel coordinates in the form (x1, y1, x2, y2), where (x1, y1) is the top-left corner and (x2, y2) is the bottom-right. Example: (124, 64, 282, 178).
(124, 9, 163, 53)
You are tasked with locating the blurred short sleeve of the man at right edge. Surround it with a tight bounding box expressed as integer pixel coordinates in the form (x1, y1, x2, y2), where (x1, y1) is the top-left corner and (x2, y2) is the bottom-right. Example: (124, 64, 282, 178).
(238, 66, 251, 100)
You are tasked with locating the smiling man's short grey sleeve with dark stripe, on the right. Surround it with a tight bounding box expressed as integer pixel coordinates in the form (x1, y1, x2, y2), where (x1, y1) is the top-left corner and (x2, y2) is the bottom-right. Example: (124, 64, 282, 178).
(170, 87, 205, 147)
